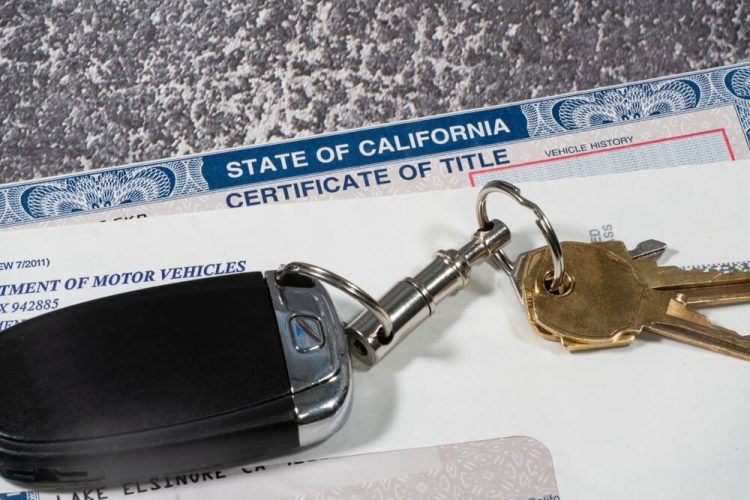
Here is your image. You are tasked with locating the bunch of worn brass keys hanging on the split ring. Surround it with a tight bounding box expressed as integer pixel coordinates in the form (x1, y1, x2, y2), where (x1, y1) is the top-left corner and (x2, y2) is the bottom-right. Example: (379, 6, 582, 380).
(513, 242, 750, 360)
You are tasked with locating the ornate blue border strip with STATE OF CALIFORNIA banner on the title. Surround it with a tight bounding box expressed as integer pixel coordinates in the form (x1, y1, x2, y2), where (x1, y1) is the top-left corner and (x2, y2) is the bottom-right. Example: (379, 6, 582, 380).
(0, 64, 750, 226)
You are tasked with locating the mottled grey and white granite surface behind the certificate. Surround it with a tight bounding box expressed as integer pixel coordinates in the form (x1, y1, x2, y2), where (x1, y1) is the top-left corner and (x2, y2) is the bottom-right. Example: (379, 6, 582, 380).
(0, 0, 750, 182)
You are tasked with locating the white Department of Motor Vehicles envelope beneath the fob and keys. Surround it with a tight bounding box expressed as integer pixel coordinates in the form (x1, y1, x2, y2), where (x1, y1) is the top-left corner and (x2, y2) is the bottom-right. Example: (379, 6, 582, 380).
(0, 161, 750, 499)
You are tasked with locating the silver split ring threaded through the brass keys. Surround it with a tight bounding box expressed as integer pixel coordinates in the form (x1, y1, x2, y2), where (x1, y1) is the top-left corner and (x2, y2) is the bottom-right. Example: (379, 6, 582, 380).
(476, 181, 565, 292)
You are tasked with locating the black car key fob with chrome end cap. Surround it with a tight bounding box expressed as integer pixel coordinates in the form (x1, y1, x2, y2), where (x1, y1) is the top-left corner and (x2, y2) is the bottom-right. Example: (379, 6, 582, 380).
(0, 272, 351, 485)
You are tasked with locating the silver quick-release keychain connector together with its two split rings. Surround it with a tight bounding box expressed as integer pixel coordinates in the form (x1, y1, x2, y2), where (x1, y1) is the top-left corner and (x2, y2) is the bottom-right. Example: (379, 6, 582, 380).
(276, 181, 572, 365)
